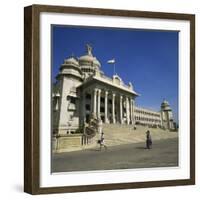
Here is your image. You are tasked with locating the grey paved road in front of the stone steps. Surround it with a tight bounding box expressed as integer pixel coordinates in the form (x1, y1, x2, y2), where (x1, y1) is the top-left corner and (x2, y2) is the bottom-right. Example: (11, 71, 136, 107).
(52, 138, 178, 172)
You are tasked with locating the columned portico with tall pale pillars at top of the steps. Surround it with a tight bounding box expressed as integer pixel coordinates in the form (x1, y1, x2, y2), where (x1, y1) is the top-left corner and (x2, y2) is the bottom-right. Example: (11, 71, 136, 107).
(80, 77, 137, 124)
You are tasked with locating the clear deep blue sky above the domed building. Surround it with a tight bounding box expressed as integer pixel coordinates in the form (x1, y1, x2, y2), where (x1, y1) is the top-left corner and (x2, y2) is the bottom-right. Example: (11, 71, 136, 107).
(52, 26, 178, 121)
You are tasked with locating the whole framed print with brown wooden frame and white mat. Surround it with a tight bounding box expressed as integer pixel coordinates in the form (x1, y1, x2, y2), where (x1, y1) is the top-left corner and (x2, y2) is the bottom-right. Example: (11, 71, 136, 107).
(24, 5, 195, 194)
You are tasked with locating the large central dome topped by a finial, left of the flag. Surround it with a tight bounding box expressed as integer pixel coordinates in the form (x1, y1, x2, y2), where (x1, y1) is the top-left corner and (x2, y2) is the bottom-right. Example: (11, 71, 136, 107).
(78, 44, 101, 76)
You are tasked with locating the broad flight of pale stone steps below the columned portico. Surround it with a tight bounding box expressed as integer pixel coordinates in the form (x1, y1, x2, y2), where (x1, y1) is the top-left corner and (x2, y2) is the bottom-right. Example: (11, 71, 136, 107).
(103, 124, 177, 146)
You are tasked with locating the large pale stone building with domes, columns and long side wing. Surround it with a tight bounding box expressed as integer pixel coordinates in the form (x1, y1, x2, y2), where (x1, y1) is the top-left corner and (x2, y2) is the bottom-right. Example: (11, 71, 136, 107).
(52, 45, 175, 135)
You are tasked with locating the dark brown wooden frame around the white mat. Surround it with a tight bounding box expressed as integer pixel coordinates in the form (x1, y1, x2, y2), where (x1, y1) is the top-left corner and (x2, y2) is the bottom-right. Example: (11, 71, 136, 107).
(24, 5, 195, 194)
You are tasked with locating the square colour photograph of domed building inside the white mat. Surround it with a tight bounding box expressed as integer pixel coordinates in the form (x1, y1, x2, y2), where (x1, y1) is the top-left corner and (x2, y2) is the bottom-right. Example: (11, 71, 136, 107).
(51, 24, 179, 173)
